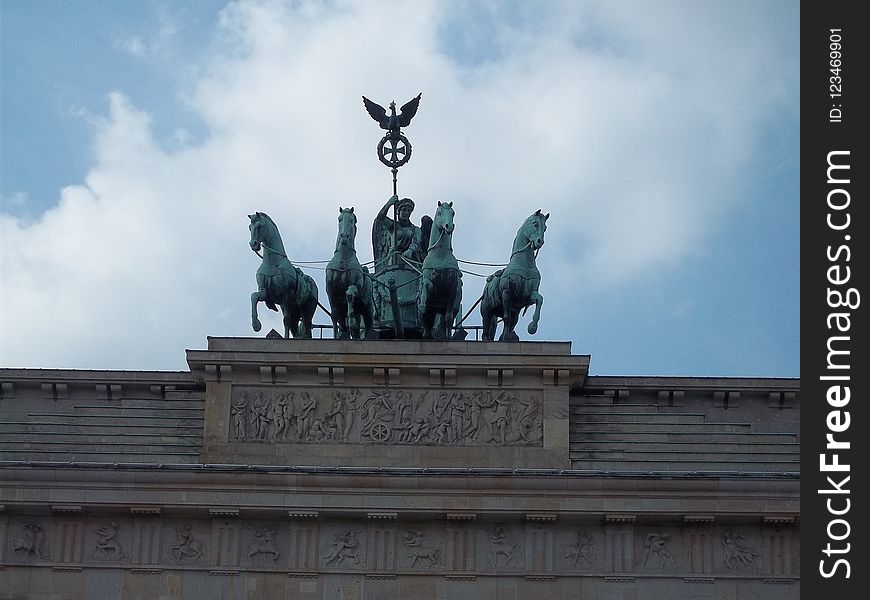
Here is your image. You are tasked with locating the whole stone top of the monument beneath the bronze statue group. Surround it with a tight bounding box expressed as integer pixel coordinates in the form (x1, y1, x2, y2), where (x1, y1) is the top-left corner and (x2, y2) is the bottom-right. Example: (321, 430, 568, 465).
(0, 338, 800, 600)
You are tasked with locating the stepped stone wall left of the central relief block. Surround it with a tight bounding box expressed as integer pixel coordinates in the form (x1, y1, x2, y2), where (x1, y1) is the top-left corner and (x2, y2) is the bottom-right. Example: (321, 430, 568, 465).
(0, 369, 204, 463)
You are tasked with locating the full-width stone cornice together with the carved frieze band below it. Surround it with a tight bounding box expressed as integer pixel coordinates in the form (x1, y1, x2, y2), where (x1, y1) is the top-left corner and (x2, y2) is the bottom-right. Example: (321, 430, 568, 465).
(0, 464, 799, 586)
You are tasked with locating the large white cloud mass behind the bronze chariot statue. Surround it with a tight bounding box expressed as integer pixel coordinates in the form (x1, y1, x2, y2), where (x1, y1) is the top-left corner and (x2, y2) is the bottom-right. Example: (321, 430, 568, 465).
(0, 1, 795, 368)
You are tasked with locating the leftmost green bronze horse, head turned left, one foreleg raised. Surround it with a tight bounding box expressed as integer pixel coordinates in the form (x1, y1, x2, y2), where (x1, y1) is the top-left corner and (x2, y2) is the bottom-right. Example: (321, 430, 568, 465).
(248, 212, 317, 338)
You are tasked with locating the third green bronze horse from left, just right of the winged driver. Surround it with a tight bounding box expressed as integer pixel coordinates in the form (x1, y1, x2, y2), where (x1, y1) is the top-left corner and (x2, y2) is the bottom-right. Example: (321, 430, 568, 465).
(417, 202, 462, 339)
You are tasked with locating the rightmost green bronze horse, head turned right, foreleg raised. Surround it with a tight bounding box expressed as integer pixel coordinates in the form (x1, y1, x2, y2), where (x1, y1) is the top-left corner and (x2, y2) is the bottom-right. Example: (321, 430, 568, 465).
(480, 210, 550, 342)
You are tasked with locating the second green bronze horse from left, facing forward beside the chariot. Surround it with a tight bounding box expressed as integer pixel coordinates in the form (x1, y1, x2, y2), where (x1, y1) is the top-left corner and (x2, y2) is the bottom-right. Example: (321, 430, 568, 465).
(326, 207, 374, 340)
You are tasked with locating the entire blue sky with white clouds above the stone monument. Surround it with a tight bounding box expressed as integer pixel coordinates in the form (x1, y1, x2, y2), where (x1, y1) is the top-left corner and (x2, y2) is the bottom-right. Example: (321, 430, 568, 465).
(0, 0, 800, 377)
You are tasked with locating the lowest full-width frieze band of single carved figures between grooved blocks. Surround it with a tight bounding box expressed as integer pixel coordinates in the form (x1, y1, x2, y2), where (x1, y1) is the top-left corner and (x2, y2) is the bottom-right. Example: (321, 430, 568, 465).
(0, 511, 799, 579)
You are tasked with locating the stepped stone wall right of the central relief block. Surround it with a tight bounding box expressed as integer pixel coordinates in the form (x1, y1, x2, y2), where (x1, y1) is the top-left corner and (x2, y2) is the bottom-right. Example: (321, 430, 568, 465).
(570, 377, 800, 473)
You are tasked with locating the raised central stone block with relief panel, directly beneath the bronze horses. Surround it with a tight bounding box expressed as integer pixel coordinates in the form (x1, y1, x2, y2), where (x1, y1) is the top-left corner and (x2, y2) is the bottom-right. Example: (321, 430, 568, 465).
(188, 338, 589, 468)
